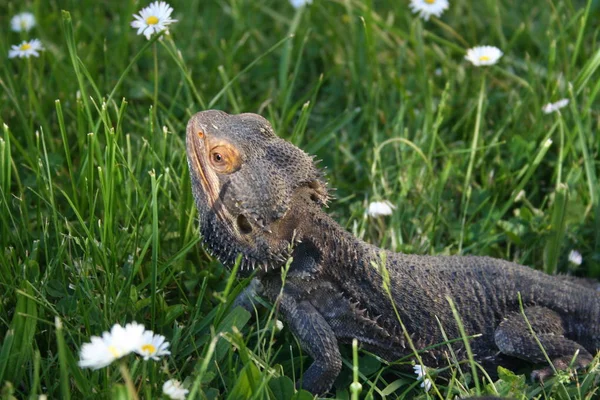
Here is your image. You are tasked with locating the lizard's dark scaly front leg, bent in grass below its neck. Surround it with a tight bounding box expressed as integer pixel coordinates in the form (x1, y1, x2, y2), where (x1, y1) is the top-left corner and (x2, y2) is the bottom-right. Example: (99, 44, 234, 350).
(279, 283, 342, 394)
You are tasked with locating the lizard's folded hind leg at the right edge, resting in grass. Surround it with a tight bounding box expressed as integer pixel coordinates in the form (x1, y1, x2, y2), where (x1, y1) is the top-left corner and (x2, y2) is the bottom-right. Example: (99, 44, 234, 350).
(495, 307, 593, 381)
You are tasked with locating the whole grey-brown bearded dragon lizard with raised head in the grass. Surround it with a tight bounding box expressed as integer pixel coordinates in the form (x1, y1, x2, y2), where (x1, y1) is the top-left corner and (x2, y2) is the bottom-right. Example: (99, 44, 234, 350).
(186, 110, 600, 394)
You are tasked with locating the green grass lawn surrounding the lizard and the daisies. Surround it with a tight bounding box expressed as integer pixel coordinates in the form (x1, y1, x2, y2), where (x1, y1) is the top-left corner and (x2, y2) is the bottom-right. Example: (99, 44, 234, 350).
(0, 0, 600, 399)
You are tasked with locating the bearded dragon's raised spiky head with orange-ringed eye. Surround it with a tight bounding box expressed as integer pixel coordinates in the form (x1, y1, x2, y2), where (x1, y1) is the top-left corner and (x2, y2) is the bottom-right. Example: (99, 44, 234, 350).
(186, 110, 328, 273)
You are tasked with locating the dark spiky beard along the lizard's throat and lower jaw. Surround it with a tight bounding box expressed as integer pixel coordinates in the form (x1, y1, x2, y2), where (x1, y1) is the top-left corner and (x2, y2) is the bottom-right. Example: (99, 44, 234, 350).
(200, 211, 291, 276)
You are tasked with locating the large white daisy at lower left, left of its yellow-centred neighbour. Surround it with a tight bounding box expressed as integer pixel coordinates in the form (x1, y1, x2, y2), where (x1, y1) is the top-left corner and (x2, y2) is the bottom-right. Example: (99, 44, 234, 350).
(79, 322, 144, 369)
